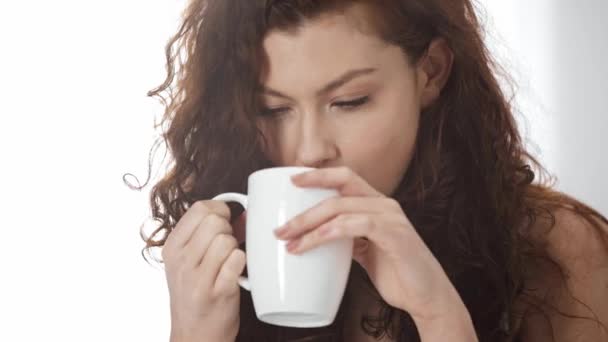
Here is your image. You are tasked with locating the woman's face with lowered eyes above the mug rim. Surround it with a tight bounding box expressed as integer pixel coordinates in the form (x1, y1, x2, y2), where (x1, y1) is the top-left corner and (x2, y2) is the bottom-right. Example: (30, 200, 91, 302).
(258, 8, 428, 195)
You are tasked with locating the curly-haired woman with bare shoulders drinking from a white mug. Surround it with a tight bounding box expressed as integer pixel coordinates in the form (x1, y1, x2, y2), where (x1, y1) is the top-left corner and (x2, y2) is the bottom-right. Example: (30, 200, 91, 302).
(133, 0, 608, 342)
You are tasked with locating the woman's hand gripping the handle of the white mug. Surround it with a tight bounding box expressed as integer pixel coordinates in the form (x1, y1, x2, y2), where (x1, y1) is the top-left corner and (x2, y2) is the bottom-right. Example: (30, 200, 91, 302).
(162, 200, 246, 342)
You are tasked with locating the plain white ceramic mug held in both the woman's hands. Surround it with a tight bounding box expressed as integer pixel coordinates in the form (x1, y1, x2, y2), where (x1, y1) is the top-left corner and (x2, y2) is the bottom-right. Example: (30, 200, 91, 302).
(213, 167, 353, 328)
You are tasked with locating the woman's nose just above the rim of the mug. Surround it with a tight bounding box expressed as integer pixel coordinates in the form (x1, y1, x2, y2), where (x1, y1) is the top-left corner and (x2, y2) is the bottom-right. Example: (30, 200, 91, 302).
(296, 115, 338, 168)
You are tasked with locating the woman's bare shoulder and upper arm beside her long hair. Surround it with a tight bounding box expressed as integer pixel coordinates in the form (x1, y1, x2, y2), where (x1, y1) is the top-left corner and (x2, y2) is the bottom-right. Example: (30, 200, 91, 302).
(516, 204, 608, 342)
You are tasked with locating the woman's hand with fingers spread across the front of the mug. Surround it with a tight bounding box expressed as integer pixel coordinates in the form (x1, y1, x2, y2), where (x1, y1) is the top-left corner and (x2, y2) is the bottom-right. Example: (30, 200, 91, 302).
(275, 167, 472, 329)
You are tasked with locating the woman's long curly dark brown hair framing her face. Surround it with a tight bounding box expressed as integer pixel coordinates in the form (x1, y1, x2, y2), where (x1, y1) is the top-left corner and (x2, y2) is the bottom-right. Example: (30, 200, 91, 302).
(124, 0, 608, 341)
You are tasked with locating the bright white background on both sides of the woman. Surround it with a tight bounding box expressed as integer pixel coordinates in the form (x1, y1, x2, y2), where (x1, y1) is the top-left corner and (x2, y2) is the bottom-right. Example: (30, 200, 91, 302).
(0, 0, 608, 341)
